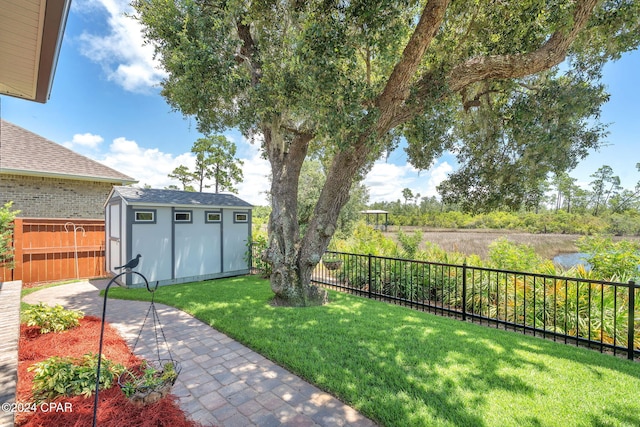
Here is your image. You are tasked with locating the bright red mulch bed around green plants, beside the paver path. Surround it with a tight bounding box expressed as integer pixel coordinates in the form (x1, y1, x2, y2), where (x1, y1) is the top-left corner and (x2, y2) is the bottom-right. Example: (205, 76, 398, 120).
(16, 316, 199, 427)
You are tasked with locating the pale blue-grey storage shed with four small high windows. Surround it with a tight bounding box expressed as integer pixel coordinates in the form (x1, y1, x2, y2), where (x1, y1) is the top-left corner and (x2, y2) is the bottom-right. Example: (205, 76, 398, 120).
(105, 186, 252, 287)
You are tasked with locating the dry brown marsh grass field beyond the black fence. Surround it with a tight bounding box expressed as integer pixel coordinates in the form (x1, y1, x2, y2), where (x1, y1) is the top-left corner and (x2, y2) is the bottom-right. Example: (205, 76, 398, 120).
(384, 227, 581, 259)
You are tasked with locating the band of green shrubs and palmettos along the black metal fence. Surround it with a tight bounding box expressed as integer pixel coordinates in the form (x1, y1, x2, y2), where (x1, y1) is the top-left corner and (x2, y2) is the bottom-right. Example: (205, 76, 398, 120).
(320, 231, 640, 348)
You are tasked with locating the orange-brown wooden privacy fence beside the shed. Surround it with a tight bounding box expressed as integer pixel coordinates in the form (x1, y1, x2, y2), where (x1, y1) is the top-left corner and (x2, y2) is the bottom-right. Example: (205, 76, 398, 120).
(0, 218, 106, 285)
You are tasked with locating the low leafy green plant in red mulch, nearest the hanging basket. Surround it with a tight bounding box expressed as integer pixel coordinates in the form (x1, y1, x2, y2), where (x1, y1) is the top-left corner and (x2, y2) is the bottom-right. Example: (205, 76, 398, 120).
(27, 353, 124, 402)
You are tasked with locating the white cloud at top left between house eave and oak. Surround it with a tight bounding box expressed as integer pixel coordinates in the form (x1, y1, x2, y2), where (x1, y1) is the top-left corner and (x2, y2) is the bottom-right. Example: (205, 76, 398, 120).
(76, 0, 166, 92)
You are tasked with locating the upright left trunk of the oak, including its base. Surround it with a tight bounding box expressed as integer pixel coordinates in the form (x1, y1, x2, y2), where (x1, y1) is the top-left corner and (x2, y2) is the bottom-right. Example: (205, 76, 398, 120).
(264, 126, 328, 307)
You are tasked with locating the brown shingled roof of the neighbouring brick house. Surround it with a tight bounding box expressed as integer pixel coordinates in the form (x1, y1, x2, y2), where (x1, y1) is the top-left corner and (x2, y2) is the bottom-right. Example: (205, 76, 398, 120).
(0, 120, 137, 184)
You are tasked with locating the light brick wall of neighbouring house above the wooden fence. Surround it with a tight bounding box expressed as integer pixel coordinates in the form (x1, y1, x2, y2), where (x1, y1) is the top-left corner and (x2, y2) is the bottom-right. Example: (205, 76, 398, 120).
(0, 175, 113, 218)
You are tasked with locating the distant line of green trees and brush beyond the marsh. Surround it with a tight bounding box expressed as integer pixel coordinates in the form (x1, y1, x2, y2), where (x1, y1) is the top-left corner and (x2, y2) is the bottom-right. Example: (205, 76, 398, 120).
(369, 163, 640, 235)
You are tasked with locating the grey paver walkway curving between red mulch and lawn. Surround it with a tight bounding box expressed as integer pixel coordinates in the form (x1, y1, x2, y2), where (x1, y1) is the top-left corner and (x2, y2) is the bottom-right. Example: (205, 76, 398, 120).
(18, 280, 375, 427)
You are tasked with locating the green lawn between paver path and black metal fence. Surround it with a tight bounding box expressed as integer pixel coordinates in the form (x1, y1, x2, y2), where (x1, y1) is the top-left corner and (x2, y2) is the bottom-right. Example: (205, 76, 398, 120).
(109, 276, 640, 427)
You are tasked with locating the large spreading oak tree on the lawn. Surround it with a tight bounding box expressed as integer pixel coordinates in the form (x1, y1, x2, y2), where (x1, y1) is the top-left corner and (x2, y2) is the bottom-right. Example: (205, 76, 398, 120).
(134, 0, 640, 305)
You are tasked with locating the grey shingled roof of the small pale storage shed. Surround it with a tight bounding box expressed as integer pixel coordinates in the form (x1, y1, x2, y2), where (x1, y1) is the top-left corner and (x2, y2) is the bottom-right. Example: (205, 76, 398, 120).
(109, 186, 253, 208)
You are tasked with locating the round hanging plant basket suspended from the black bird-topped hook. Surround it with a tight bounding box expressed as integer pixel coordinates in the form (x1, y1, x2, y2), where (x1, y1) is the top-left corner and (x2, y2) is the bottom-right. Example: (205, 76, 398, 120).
(118, 359, 182, 406)
